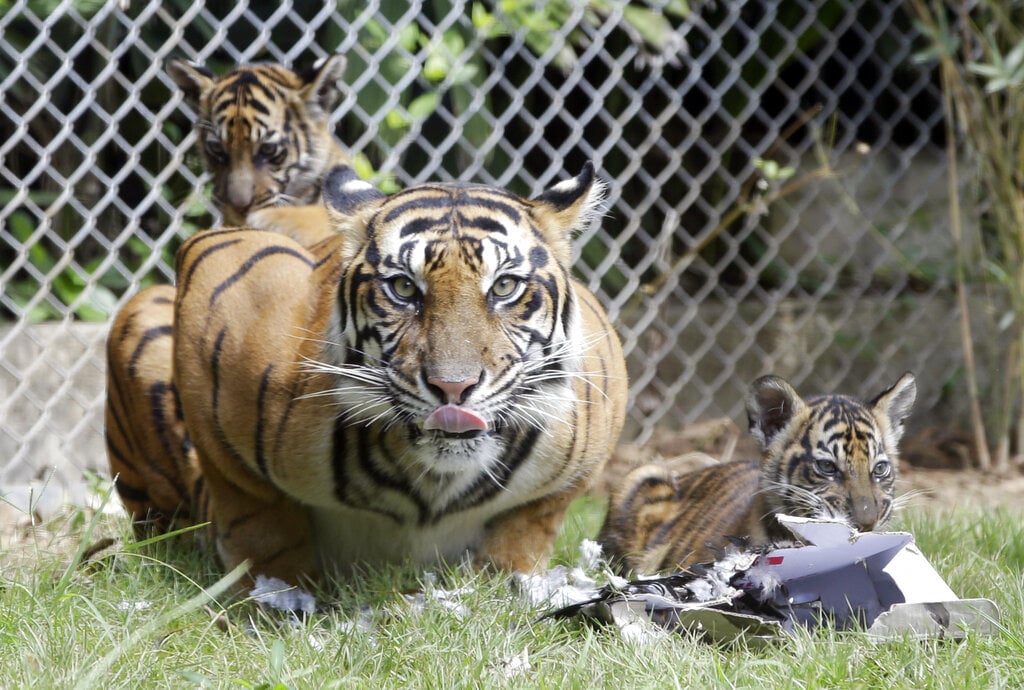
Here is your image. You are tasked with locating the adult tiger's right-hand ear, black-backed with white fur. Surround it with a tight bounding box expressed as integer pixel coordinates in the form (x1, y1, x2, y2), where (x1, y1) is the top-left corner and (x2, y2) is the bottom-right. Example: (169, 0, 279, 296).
(529, 161, 604, 264)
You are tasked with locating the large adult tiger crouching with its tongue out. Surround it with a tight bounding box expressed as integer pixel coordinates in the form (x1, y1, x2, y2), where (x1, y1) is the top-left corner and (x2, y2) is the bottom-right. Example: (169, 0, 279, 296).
(106, 164, 627, 583)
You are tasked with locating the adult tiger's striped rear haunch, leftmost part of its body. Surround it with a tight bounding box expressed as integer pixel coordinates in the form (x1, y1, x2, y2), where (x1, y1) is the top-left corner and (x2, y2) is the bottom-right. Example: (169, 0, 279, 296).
(105, 286, 204, 529)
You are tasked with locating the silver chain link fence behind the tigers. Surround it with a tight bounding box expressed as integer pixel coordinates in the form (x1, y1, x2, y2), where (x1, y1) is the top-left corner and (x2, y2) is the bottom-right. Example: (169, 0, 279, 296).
(0, 0, 987, 505)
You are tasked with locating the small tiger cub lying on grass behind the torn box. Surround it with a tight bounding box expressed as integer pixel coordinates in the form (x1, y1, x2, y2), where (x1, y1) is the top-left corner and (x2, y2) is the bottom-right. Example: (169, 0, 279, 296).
(598, 374, 916, 573)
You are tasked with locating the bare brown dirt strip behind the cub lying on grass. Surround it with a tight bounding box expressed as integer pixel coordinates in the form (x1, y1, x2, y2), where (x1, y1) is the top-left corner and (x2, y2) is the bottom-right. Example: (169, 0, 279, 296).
(599, 418, 1024, 516)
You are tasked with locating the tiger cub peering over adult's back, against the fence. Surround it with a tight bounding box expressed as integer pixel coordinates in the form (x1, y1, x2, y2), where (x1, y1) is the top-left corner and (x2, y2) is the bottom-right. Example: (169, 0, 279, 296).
(167, 55, 349, 241)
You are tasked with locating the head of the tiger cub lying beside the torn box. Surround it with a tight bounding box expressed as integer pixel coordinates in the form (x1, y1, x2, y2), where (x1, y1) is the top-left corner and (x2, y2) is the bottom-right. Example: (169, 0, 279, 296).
(746, 374, 916, 531)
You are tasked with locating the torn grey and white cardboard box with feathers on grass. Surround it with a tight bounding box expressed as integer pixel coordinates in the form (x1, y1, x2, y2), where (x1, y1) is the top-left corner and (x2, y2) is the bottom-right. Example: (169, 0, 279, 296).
(549, 516, 998, 643)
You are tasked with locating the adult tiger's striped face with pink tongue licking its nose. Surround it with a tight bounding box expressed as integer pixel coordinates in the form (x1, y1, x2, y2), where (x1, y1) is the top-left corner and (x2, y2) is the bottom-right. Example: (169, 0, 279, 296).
(325, 166, 600, 471)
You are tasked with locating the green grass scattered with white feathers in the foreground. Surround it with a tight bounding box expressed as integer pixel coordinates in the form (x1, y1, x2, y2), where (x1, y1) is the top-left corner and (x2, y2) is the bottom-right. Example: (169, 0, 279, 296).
(0, 501, 1024, 690)
